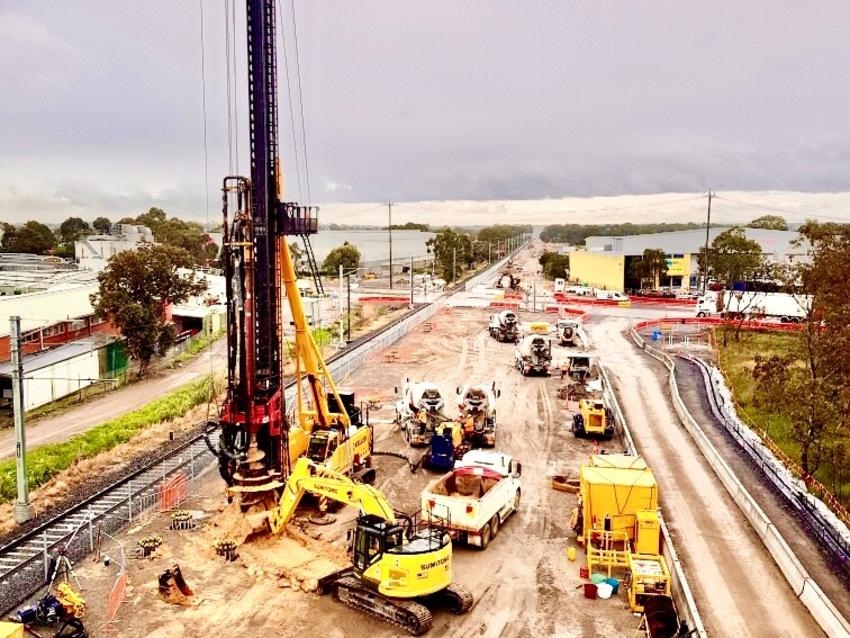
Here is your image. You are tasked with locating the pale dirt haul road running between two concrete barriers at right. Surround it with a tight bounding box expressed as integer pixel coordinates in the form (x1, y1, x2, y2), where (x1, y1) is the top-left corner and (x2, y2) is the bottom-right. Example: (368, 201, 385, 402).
(588, 317, 823, 638)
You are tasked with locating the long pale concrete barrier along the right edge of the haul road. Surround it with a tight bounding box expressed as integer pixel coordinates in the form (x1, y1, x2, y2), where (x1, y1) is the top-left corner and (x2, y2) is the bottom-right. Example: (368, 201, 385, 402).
(631, 329, 850, 638)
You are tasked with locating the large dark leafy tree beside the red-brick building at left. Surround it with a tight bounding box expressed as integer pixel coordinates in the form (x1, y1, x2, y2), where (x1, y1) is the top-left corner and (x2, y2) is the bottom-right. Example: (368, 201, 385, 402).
(91, 244, 206, 376)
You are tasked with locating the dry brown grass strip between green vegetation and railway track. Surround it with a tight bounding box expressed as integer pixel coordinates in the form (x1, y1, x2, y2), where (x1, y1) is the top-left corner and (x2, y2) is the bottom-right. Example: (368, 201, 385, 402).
(0, 404, 215, 544)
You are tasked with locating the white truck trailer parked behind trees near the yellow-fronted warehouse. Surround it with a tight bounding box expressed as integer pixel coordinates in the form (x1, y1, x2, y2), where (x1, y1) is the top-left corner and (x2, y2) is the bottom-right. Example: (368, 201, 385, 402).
(695, 290, 812, 323)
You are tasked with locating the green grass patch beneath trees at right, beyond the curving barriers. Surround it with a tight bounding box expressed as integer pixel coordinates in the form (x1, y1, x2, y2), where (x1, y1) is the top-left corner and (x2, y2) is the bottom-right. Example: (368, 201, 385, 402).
(717, 331, 848, 503)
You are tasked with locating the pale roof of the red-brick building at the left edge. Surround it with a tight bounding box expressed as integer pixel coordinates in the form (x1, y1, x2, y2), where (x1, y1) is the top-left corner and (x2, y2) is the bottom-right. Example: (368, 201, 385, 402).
(0, 284, 98, 336)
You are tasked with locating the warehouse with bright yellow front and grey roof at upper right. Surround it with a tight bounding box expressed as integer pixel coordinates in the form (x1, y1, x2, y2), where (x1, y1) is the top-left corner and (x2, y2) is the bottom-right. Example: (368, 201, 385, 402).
(570, 226, 806, 290)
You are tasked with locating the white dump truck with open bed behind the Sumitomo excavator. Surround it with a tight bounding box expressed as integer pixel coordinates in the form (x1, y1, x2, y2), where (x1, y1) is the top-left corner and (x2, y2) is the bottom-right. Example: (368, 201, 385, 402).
(422, 450, 522, 549)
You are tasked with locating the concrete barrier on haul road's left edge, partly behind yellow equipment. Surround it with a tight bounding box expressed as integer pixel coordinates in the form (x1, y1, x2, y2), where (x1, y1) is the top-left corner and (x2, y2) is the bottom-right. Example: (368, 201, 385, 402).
(598, 365, 708, 638)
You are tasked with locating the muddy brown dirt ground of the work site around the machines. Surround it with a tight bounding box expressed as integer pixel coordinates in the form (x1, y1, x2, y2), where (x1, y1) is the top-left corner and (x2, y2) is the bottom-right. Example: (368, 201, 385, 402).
(73, 309, 638, 638)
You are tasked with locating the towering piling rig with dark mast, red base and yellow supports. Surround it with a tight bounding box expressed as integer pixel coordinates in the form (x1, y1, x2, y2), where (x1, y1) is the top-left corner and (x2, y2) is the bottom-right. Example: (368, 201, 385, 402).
(209, 0, 364, 510)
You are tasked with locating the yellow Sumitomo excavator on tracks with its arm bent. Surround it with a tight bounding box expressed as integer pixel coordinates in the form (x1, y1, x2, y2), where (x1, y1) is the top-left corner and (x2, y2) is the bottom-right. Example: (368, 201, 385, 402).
(269, 457, 473, 636)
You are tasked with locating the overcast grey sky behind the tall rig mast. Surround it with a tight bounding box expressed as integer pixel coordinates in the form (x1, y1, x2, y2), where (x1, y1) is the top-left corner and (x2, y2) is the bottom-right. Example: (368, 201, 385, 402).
(0, 0, 850, 228)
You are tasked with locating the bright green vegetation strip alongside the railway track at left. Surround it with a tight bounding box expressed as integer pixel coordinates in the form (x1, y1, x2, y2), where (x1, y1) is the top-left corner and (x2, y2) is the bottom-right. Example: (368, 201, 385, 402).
(0, 375, 211, 503)
